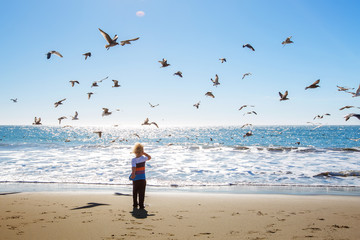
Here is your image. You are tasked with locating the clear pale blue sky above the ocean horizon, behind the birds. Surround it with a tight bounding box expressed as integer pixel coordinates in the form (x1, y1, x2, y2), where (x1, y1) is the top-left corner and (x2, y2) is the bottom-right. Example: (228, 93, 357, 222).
(0, 0, 360, 127)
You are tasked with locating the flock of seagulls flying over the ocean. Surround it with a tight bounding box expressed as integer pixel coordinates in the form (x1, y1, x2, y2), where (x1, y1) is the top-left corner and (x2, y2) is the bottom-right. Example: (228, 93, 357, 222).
(10, 28, 360, 141)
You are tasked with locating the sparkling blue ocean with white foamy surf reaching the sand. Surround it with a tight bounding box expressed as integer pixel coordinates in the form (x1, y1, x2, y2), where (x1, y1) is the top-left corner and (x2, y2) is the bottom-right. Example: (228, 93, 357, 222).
(0, 126, 360, 195)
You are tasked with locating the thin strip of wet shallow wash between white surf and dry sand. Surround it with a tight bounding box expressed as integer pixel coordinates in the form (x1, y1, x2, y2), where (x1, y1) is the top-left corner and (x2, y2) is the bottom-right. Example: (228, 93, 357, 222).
(0, 182, 360, 196)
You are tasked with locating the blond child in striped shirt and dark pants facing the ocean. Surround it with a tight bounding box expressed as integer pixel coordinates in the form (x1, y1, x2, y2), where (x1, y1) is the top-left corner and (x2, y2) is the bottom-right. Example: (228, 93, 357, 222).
(130, 143, 151, 209)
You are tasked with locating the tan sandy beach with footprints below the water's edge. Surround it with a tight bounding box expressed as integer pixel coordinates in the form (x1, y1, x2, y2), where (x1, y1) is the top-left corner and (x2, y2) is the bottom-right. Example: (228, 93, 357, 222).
(0, 192, 360, 240)
